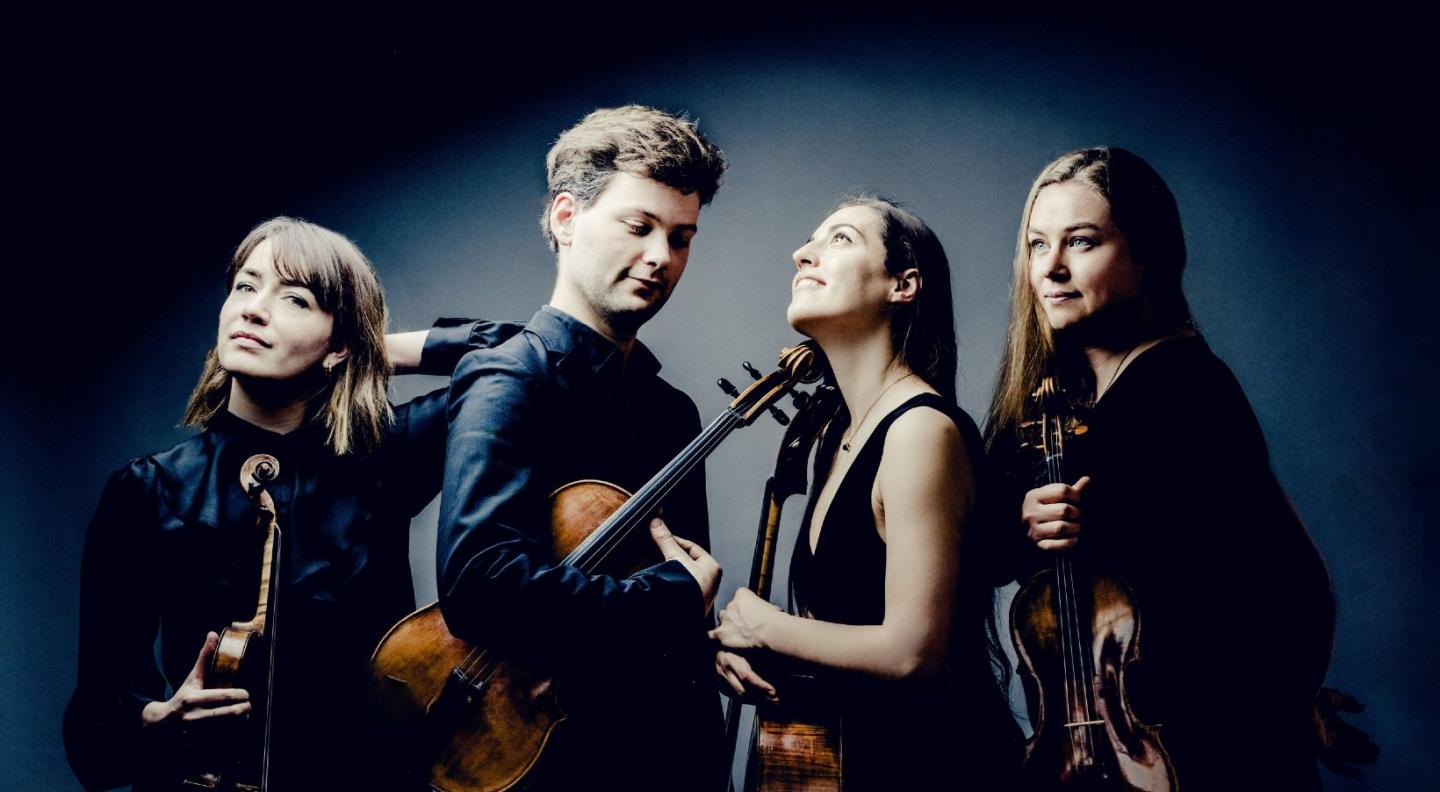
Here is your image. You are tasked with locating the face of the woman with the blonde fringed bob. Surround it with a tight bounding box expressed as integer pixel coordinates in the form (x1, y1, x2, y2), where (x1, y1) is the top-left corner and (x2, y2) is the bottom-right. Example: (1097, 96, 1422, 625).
(216, 239, 347, 382)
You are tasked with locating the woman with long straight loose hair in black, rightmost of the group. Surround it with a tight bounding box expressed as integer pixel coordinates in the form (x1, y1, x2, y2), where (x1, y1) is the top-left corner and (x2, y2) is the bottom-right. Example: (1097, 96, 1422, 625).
(986, 147, 1335, 791)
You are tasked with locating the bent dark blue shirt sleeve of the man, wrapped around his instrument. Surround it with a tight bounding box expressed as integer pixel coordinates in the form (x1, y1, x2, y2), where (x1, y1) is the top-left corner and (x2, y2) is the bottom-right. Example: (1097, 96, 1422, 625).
(436, 350, 703, 661)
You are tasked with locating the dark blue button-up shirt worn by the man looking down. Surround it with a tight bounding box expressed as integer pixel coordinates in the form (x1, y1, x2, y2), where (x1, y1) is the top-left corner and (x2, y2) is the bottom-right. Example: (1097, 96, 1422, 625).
(438, 307, 720, 789)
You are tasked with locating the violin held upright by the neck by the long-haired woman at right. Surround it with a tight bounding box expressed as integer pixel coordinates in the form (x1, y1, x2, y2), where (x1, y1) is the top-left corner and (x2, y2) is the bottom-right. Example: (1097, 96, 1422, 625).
(1009, 377, 1179, 792)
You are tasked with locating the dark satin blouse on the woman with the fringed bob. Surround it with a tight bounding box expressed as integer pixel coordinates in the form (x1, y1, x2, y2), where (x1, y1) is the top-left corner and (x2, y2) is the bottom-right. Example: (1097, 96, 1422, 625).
(65, 323, 518, 791)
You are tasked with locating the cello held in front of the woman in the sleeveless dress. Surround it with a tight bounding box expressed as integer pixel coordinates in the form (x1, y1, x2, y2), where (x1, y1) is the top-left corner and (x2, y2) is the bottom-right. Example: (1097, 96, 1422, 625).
(726, 374, 841, 792)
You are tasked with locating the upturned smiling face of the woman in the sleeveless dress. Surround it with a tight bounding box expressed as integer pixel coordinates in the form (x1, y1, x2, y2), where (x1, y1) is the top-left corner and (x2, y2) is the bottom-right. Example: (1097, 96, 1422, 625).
(785, 206, 896, 337)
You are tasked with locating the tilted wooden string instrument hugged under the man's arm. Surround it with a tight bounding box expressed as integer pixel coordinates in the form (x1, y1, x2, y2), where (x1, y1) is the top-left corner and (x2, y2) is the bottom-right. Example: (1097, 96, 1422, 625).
(372, 344, 818, 792)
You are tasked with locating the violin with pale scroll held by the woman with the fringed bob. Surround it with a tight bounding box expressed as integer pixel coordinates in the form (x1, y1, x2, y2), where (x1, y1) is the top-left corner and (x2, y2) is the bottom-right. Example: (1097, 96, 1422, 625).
(184, 454, 282, 792)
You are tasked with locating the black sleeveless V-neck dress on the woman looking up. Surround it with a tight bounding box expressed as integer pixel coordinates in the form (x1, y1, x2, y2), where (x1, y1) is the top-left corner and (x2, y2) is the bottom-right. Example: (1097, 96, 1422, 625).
(791, 393, 1022, 792)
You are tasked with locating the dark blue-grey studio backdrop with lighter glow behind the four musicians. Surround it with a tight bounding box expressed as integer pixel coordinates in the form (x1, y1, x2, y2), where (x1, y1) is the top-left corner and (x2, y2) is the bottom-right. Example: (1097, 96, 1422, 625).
(8, 7, 1440, 789)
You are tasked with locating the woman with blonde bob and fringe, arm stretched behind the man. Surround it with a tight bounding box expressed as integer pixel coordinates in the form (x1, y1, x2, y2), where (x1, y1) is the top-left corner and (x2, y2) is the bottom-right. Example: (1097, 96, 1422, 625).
(65, 217, 513, 792)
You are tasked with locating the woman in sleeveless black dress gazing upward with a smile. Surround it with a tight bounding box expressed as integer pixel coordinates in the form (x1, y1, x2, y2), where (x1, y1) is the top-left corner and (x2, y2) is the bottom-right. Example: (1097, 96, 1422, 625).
(713, 197, 1020, 791)
